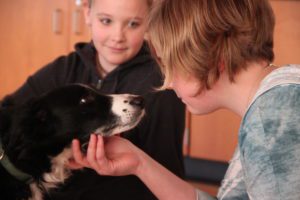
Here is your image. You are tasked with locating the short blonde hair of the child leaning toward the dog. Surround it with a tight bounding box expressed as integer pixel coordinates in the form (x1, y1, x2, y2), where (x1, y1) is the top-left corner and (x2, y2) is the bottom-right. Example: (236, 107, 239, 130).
(148, 0, 275, 89)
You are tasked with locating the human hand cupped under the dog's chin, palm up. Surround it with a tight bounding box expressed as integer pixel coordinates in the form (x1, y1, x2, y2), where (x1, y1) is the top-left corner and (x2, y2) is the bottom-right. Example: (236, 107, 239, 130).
(69, 134, 141, 176)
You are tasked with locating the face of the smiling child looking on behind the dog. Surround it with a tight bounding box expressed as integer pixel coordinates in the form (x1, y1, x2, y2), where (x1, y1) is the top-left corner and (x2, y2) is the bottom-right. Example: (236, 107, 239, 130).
(85, 0, 149, 68)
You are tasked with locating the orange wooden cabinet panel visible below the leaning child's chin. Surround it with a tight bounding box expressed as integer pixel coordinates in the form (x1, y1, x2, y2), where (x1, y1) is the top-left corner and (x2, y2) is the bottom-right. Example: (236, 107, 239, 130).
(190, 109, 240, 162)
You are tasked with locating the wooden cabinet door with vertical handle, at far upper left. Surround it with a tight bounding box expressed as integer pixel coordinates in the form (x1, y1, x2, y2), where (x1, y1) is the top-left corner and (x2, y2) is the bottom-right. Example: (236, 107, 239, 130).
(0, 0, 69, 98)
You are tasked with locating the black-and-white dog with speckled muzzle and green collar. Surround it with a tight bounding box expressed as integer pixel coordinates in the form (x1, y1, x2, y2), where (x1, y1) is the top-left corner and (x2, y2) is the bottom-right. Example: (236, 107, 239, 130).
(0, 84, 145, 200)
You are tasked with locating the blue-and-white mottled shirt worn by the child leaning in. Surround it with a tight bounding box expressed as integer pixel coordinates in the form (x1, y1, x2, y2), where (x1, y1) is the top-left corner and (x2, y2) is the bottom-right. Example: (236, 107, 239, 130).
(197, 65, 300, 200)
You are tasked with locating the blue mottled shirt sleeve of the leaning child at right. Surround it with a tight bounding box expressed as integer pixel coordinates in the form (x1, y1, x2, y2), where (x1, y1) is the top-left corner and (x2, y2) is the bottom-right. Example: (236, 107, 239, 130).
(239, 84, 300, 200)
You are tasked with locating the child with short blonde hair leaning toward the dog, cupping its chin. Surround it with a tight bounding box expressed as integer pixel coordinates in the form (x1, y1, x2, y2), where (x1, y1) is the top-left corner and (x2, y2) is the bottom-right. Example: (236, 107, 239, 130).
(73, 0, 300, 200)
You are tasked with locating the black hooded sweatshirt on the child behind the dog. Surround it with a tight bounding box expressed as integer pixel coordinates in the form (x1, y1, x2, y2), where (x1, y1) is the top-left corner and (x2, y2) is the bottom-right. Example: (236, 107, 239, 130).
(13, 42, 185, 200)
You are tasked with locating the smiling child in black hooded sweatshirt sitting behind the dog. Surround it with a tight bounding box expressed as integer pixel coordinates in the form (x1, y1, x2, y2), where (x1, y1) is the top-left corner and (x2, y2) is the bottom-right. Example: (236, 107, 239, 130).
(14, 0, 185, 200)
